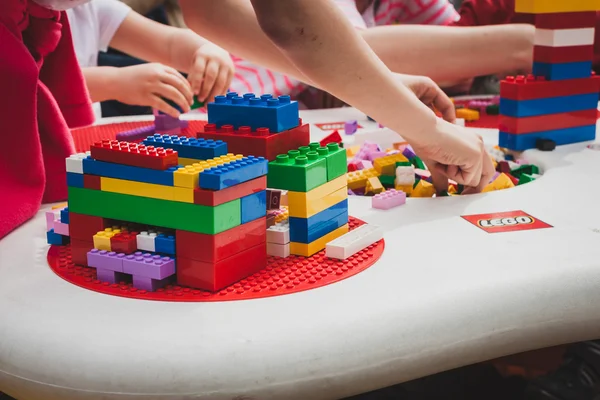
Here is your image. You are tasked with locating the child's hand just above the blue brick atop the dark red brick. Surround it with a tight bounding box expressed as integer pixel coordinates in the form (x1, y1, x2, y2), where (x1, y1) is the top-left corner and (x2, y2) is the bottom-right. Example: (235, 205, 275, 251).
(188, 43, 235, 102)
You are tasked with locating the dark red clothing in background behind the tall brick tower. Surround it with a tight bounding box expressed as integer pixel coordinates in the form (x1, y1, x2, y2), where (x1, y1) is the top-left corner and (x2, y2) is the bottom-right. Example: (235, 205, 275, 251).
(455, 0, 600, 73)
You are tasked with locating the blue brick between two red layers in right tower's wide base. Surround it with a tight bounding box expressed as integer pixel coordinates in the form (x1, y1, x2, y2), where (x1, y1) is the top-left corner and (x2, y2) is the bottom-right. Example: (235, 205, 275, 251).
(500, 93, 598, 117)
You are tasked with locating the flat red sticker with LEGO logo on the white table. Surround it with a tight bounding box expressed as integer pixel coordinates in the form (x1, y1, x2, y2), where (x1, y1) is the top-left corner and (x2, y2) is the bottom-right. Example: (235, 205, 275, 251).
(462, 211, 552, 233)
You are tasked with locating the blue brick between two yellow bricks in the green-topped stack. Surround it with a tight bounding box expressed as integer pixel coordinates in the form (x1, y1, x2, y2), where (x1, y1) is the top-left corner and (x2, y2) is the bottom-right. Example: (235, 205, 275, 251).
(289, 199, 348, 243)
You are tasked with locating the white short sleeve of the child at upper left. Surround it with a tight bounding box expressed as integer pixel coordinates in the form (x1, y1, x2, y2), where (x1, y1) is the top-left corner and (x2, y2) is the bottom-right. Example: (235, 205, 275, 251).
(67, 0, 131, 118)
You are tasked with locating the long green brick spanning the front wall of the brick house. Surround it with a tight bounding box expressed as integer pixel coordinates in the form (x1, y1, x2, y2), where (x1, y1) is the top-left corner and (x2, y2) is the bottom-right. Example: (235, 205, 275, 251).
(69, 187, 242, 235)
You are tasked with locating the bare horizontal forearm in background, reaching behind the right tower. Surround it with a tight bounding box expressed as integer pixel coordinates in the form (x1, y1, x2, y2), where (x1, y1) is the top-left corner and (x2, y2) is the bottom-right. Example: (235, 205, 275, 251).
(360, 24, 534, 82)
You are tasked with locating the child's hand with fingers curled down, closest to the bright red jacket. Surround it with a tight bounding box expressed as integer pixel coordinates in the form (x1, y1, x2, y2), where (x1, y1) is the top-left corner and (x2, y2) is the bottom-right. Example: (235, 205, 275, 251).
(113, 63, 193, 117)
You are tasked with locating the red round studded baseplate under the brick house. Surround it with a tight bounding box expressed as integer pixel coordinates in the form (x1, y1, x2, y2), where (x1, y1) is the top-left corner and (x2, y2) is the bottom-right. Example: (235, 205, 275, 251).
(48, 217, 385, 302)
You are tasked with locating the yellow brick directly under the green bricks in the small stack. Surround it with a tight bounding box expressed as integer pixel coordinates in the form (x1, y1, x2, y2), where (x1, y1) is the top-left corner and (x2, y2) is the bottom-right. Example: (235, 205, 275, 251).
(287, 176, 348, 218)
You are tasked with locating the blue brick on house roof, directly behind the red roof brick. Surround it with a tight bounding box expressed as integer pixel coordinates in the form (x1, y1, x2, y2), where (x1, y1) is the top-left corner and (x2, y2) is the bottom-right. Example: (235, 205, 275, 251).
(144, 133, 227, 160)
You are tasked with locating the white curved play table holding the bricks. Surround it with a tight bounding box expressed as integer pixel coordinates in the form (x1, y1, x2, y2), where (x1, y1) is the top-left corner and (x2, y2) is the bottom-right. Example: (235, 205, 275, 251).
(0, 110, 600, 400)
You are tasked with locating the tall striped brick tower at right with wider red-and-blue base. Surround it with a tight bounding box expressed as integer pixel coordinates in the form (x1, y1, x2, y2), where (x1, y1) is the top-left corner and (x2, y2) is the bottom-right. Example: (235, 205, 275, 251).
(499, 0, 600, 151)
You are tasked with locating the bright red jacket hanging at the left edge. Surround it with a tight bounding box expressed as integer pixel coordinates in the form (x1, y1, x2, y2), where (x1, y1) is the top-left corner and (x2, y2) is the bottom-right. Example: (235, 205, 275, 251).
(0, 0, 93, 238)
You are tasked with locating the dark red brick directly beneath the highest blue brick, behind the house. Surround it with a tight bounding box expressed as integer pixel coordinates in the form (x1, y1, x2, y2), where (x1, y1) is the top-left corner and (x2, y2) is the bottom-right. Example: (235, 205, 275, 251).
(196, 120, 310, 161)
